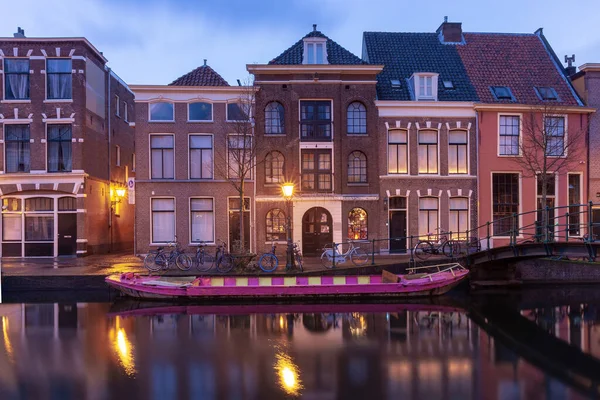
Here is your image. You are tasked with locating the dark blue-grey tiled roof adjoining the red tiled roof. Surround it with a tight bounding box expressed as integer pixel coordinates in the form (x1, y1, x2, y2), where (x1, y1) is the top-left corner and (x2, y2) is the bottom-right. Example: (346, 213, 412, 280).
(363, 32, 479, 101)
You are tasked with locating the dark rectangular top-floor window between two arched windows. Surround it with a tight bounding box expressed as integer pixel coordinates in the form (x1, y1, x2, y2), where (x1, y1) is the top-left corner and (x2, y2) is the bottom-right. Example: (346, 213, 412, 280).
(300, 101, 331, 141)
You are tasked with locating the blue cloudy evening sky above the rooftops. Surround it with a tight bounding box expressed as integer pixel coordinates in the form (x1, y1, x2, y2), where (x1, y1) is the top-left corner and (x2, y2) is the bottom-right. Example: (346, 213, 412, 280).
(0, 0, 600, 85)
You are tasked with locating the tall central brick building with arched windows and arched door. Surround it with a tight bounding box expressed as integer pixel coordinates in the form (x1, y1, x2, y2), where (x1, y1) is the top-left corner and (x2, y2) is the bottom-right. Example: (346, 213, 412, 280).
(247, 25, 382, 256)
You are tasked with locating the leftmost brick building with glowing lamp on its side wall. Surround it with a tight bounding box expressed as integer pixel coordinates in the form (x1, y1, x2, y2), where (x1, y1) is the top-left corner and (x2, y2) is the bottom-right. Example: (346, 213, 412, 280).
(0, 28, 134, 257)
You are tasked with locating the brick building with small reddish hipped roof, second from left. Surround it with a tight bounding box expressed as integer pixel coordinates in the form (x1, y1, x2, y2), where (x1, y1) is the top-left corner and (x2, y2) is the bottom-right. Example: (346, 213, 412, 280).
(131, 62, 254, 254)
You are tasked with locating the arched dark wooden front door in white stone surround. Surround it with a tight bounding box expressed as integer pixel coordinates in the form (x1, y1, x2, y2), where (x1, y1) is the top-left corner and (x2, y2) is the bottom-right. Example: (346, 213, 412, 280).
(302, 207, 333, 256)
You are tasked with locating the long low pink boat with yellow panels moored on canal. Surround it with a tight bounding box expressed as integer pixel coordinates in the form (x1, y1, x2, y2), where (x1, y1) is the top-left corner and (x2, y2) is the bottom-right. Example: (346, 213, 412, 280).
(106, 263, 469, 300)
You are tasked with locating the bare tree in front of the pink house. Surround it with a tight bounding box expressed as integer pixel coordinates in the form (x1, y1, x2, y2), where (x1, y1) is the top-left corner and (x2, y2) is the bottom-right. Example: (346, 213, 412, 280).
(508, 104, 587, 239)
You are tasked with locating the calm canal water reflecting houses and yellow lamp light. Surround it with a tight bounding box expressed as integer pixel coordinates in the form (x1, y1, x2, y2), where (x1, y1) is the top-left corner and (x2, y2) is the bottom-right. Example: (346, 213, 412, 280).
(0, 301, 600, 400)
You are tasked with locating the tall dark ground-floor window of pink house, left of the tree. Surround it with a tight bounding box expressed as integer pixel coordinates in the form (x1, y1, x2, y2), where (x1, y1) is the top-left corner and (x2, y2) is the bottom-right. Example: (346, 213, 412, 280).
(492, 173, 520, 236)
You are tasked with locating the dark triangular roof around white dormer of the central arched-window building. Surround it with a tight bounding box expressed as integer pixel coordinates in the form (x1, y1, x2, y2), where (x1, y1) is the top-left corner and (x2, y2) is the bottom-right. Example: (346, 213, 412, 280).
(269, 29, 367, 65)
